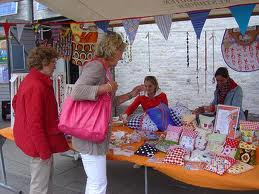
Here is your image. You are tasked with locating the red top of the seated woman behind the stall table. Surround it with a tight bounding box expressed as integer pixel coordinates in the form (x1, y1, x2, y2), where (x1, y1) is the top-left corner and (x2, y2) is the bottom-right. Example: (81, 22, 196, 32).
(125, 92, 168, 116)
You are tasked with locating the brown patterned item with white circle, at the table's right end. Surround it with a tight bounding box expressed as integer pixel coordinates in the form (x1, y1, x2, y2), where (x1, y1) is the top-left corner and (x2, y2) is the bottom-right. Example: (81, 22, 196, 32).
(235, 141, 256, 165)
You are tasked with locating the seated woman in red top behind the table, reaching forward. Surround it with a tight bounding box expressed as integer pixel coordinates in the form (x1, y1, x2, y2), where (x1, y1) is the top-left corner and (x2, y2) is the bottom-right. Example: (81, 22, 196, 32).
(123, 76, 168, 119)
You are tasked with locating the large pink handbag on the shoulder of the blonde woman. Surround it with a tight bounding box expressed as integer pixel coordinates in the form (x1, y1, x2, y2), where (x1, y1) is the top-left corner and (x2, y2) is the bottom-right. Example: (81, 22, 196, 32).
(58, 59, 112, 143)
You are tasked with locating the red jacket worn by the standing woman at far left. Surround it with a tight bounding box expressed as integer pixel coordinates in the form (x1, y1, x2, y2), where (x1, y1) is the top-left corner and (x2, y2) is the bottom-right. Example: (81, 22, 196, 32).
(13, 68, 69, 160)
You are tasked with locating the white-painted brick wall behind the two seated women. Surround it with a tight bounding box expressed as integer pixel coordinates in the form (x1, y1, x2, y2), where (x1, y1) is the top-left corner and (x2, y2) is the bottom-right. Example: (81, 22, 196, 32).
(115, 17, 259, 113)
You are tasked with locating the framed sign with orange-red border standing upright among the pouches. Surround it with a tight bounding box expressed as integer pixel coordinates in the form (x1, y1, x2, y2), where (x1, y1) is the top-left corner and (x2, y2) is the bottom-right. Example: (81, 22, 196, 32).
(214, 104, 240, 139)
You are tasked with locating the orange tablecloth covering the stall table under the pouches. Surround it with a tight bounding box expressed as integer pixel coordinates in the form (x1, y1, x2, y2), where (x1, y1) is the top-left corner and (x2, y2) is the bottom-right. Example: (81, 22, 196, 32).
(0, 127, 259, 190)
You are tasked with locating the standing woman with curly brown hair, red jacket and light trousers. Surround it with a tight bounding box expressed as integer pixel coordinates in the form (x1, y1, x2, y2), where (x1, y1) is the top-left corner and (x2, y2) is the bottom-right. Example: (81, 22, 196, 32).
(12, 47, 69, 194)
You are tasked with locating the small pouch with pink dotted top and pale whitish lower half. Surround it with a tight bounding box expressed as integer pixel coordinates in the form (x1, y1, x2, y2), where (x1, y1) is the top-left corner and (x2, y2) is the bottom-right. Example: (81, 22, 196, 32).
(179, 129, 198, 151)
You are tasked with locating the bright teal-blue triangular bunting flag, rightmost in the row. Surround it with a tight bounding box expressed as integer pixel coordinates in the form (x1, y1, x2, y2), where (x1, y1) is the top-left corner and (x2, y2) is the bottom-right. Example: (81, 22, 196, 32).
(229, 4, 255, 35)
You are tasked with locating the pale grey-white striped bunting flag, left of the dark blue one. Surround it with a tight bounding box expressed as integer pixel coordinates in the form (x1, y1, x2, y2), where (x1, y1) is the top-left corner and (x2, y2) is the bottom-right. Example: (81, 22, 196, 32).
(155, 15, 172, 40)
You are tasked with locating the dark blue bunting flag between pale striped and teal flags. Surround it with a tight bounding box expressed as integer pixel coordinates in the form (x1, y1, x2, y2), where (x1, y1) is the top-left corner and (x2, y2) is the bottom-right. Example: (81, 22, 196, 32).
(188, 10, 210, 39)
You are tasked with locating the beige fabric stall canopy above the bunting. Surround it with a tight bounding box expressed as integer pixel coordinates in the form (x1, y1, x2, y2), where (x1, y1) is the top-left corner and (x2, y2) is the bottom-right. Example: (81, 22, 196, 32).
(37, 0, 259, 24)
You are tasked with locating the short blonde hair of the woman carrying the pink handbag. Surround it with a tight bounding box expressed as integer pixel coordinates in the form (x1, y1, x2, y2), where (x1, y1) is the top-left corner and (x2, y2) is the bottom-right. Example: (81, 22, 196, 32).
(95, 32, 126, 59)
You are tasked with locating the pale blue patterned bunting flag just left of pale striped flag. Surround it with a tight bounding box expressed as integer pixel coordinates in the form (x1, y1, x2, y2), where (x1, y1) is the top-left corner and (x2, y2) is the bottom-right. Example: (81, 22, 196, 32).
(122, 19, 140, 44)
